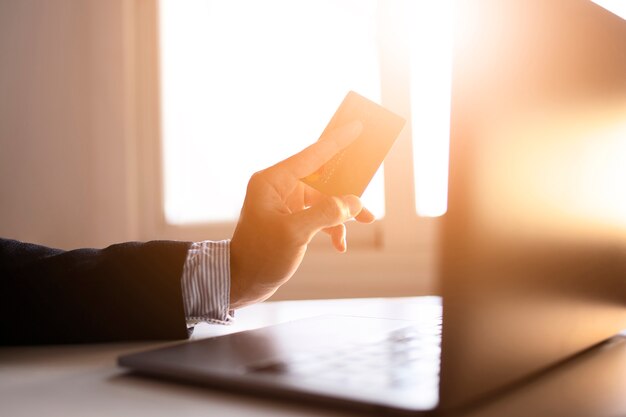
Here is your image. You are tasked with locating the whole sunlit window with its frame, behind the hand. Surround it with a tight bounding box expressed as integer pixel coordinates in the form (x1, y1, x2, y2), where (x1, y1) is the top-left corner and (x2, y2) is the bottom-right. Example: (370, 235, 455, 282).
(137, 0, 453, 298)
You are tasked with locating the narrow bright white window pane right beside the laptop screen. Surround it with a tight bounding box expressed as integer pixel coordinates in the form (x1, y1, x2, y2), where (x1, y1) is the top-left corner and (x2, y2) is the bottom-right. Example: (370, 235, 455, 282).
(407, 0, 454, 217)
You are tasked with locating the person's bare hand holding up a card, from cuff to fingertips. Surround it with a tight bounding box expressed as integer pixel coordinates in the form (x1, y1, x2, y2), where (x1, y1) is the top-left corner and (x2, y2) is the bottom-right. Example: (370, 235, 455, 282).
(230, 122, 374, 308)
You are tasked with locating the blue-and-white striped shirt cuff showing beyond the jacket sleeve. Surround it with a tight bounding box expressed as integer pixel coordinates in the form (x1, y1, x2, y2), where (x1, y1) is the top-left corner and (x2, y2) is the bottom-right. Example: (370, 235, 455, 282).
(181, 240, 234, 326)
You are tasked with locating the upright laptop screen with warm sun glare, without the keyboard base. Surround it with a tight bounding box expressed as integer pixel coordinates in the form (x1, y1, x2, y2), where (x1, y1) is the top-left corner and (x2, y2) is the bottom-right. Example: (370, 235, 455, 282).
(440, 0, 626, 406)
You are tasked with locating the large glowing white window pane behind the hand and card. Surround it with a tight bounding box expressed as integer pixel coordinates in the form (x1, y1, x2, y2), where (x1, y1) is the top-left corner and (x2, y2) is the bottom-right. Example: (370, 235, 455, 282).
(160, 0, 384, 224)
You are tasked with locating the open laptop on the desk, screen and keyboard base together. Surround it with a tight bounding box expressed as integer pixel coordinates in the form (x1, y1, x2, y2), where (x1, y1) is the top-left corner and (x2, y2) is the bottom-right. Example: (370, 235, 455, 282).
(119, 0, 626, 415)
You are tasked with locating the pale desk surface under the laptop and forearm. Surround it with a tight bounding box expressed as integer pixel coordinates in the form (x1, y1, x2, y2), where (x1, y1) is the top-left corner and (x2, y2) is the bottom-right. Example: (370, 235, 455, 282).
(0, 298, 626, 417)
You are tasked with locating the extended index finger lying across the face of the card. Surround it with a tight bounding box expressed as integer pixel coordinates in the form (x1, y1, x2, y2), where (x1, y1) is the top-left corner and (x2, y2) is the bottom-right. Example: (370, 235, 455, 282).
(275, 121, 363, 179)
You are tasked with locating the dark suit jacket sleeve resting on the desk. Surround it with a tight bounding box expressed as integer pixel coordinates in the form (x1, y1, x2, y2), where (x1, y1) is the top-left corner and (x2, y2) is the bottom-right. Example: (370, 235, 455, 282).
(0, 239, 189, 344)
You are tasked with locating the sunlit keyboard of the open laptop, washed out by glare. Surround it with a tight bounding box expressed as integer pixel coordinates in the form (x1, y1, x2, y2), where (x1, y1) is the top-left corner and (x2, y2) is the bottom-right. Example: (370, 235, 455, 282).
(248, 320, 441, 389)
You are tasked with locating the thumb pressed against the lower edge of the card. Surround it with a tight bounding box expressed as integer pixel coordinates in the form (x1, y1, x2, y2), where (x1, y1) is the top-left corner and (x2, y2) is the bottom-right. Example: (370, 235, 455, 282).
(292, 195, 363, 239)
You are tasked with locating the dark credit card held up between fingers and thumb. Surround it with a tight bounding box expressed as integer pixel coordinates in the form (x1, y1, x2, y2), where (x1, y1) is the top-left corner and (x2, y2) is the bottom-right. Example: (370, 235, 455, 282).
(302, 91, 406, 197)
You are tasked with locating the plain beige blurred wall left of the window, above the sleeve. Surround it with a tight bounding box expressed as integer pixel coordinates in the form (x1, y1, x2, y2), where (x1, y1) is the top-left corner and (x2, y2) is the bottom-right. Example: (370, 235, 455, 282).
(0, 0, 137, 248)
